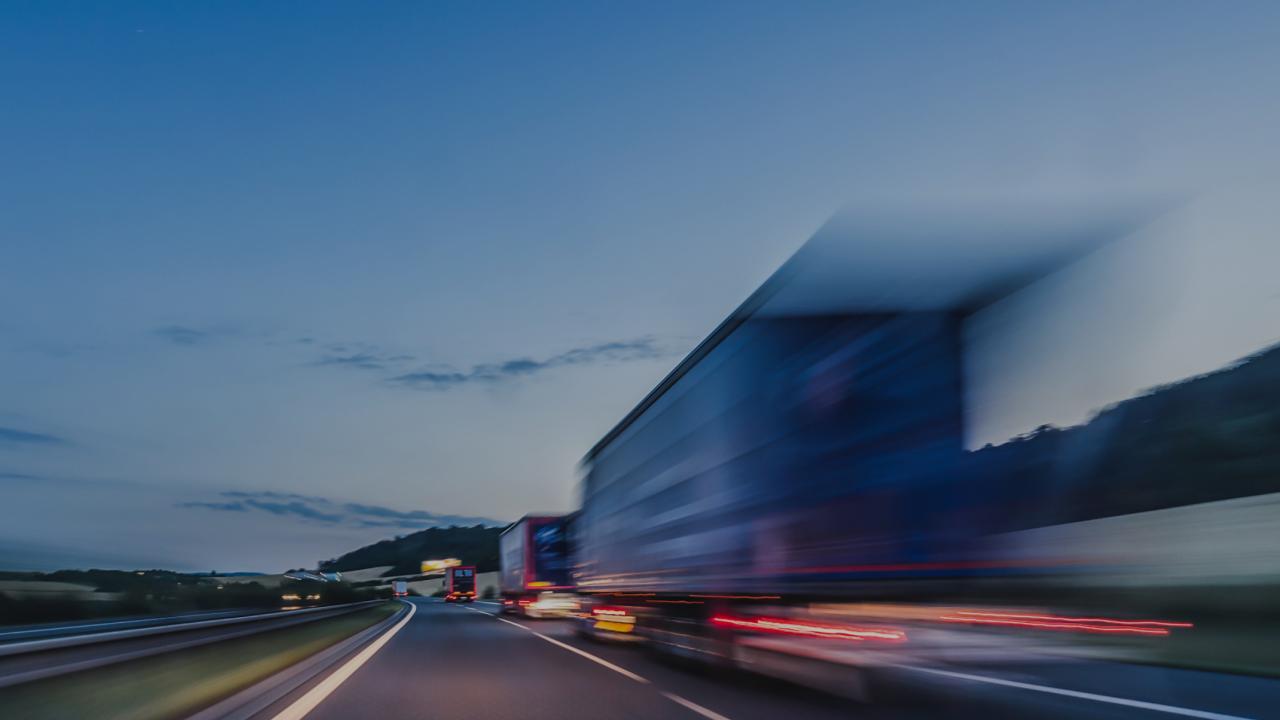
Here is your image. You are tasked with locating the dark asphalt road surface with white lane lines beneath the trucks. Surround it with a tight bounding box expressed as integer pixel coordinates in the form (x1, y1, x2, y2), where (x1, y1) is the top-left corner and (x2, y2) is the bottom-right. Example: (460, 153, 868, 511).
(275, 600, 1280, 720)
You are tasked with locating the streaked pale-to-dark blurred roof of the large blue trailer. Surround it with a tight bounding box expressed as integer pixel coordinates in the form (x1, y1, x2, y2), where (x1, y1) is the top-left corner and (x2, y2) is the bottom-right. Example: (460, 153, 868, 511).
(582, 192, 1180, 465)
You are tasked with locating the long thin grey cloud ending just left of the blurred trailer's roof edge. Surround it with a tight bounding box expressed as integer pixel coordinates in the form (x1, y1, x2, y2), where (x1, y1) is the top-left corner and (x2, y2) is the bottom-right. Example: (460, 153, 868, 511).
(388, 337, 664, 391)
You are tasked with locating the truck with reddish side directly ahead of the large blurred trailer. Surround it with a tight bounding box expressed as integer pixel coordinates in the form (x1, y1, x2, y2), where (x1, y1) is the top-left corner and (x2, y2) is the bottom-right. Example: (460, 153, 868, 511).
(498, 515, 577, 618)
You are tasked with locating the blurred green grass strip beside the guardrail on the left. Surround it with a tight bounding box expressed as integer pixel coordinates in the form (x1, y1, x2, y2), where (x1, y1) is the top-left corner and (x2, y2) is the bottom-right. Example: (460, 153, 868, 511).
(0, 602, 399, 720)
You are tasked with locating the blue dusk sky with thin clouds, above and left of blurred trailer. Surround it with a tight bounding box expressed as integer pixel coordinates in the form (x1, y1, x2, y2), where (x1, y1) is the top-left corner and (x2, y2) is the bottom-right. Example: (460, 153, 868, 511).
(0, 1, 1280, 570)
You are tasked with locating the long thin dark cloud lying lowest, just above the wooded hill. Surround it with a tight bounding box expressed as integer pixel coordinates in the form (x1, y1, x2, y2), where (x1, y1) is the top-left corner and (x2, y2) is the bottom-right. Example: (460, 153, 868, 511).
(177, 491, 503, 530)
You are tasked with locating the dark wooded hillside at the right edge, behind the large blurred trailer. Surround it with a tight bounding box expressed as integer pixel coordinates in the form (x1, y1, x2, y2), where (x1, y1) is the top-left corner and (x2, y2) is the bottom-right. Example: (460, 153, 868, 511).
(950, 338, 1280, 532)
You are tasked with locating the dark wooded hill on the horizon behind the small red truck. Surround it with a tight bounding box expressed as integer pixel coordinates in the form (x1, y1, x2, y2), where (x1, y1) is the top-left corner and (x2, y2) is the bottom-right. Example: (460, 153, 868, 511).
(320, 525, 502, 575)
